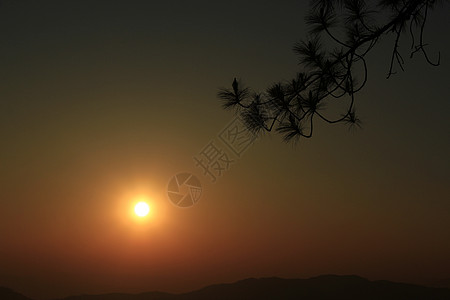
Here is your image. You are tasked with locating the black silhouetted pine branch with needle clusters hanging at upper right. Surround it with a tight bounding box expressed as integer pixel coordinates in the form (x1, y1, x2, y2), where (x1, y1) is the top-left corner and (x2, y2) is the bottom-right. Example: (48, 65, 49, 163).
(218, 0, 444, 142)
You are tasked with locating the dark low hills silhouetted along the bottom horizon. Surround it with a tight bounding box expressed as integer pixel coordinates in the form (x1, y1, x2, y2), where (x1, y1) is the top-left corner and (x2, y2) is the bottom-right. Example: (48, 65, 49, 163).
(0, 275, 450, 300)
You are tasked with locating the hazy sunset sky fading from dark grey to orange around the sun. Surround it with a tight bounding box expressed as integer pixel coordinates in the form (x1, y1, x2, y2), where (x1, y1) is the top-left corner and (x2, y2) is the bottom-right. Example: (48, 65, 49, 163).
(0, 0, 450, 299)
